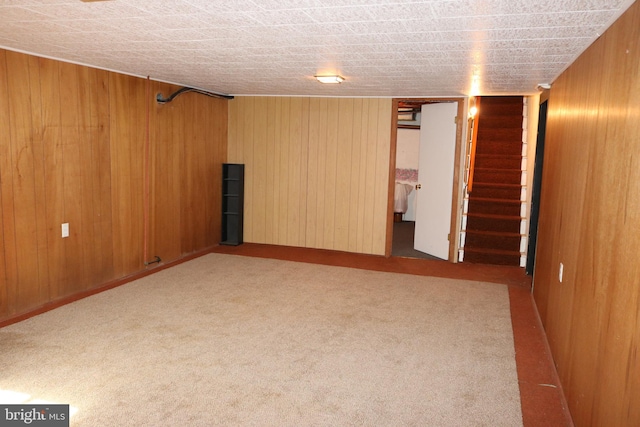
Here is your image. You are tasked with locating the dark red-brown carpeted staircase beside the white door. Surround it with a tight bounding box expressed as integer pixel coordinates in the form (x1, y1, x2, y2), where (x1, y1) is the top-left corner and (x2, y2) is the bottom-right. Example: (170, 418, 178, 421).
(464, 96, 523, 266)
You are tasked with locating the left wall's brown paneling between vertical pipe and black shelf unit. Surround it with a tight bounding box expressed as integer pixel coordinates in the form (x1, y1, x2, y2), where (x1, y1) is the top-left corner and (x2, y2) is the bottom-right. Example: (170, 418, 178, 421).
(147, 83, 227, 261)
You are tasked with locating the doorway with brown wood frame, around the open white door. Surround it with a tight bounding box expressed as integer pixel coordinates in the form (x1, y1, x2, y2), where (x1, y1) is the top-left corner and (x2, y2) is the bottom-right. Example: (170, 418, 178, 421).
(386, 98, 466, 262)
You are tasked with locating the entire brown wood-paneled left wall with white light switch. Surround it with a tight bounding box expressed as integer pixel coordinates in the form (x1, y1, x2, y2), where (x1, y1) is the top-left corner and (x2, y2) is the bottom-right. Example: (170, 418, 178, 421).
(0, 50, 227, 320)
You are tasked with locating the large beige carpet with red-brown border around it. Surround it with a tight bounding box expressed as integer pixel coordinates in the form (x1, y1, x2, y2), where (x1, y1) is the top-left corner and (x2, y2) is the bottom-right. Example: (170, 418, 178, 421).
(0, 254, 522, 427)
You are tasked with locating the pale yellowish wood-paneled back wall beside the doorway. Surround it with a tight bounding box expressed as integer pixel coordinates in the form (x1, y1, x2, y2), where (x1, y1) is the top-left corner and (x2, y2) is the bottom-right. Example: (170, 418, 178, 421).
(228, 97, 392, 255)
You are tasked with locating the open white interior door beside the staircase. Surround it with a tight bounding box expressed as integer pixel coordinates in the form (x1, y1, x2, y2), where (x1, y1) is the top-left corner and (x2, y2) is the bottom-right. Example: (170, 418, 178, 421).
(413, 102, 458, 259)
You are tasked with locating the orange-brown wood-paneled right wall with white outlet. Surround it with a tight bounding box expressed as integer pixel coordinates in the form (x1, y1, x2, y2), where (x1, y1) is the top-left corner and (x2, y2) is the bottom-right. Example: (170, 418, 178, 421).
(534, 2, 640, 426)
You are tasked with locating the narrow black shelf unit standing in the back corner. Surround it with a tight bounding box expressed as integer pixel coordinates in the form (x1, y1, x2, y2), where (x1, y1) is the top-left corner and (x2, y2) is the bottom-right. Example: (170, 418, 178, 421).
(220, 163, 244, 245)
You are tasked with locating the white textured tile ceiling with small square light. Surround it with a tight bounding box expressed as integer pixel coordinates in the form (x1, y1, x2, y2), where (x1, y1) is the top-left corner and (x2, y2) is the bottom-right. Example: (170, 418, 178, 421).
(0, 0, 633, 96)
